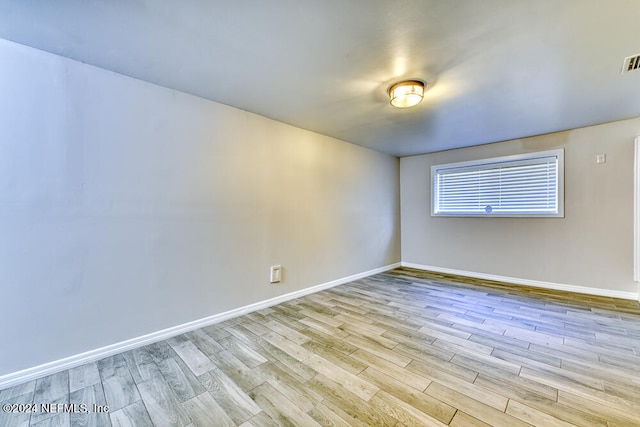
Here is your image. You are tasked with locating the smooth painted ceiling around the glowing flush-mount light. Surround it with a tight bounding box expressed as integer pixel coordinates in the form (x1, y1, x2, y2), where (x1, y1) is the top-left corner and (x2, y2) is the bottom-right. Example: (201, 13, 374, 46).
(0, 0, 640, 156)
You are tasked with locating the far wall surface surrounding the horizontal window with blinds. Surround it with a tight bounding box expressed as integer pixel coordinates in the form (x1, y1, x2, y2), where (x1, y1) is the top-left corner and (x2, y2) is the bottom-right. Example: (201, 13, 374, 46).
(400, 119, 640, 294)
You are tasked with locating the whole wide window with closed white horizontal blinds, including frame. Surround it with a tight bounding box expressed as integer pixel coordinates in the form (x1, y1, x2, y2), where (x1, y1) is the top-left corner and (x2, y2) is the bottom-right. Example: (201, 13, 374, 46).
(431, 150, 564, 217)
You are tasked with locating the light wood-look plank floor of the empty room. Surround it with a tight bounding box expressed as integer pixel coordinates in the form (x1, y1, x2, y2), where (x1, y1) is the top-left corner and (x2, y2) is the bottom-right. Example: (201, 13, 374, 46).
(0, 269, 640, 427)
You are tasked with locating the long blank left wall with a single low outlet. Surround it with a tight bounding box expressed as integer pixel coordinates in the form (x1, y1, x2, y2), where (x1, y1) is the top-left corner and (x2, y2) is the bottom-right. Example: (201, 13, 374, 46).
(0, 40, 400, 375)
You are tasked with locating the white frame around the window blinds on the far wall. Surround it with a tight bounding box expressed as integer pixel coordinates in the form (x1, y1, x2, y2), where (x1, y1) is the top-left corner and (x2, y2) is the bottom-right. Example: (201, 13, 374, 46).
(431, 148, 564, 218)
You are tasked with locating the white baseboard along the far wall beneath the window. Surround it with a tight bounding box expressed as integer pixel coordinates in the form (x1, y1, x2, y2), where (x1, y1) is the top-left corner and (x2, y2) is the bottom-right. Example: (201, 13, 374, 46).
(402, 262, 640, 300)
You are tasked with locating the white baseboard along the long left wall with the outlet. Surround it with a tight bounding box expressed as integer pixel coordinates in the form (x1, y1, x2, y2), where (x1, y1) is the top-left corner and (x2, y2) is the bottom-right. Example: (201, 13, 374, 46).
(0, 262, 401, 390)
